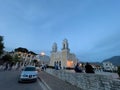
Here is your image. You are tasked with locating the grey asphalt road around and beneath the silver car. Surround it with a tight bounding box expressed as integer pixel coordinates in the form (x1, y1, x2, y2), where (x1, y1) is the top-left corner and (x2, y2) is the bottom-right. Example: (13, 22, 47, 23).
(0, 71, 43, 90)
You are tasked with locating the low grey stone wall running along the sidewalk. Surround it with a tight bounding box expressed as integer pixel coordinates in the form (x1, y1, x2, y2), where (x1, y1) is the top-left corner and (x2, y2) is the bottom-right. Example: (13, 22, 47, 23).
(47, 69, 120, 90)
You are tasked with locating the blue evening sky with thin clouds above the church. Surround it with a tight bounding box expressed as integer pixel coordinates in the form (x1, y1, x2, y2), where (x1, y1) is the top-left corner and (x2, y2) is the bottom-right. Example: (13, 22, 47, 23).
(0, 0, 120, 62)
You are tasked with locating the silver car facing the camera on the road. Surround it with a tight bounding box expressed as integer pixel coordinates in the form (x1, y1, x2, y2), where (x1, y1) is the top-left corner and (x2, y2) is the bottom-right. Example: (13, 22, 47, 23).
(18, 66, 38, 82)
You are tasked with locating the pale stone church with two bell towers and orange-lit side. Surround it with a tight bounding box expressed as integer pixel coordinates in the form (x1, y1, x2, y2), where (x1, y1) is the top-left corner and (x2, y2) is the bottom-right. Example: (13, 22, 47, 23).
(50, 39, 78, 68)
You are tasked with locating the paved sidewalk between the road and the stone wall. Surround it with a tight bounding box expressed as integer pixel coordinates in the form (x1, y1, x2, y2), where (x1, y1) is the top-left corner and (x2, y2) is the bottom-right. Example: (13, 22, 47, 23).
(39, 71, 81, 90)
